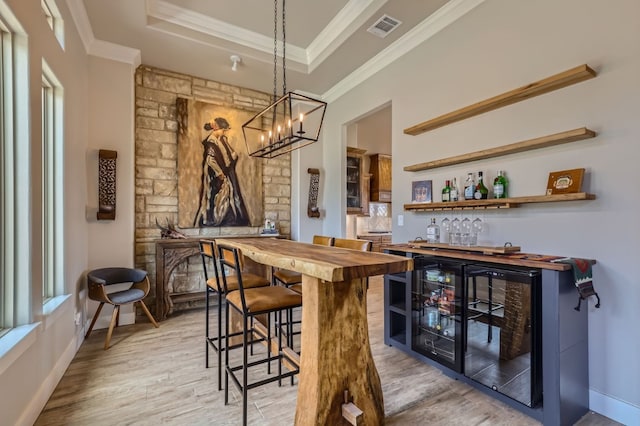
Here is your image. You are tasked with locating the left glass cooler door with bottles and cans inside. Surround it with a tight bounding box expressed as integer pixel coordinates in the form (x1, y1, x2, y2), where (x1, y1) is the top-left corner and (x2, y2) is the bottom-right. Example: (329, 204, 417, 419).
(412, 258, 462, 372)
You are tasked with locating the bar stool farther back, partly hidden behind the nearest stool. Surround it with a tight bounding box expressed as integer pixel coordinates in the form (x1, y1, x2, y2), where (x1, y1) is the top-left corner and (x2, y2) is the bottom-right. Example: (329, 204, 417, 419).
(200, 240, 270, 390)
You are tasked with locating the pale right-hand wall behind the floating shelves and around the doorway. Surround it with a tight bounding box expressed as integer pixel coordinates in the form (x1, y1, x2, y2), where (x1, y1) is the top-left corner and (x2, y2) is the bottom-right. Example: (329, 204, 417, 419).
(301, 0, 640, 424)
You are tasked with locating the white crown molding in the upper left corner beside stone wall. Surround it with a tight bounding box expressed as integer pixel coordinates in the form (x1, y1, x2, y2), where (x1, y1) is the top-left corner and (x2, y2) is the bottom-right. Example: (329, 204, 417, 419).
(67, 0, 142, 68)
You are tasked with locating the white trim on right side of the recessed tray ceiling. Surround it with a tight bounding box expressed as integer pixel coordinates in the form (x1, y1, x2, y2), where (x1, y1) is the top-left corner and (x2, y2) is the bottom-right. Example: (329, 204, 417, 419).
(307, 0, 388, 72)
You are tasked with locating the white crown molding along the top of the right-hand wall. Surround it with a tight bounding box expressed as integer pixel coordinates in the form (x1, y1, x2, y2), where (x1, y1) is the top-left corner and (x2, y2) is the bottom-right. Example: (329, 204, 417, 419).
(321, 0, 485, 102)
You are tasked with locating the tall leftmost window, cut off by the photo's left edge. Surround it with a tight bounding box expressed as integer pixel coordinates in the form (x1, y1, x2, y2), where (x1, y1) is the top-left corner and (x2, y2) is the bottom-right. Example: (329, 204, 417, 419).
(0, 1, 33, 334)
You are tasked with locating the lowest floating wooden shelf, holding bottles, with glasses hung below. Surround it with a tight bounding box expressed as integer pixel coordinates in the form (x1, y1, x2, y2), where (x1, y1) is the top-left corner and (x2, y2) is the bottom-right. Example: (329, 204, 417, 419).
(404, 192, 596, 212)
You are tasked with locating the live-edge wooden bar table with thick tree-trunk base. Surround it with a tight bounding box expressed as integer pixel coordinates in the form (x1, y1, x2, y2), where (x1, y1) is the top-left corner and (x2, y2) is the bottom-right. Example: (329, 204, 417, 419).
(216, 238, 413, 426)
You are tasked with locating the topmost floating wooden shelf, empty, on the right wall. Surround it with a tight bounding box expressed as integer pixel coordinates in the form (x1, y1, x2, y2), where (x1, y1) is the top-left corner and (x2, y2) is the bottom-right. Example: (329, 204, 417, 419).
(404, 64, 596, 136)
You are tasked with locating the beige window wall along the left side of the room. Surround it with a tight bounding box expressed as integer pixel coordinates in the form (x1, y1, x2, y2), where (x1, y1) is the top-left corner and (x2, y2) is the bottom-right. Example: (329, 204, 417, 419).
(0, 0, 89, 425)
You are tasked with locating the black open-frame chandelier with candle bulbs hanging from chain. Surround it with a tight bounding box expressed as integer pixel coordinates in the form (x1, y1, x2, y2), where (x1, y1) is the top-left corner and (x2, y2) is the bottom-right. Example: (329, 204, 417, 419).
(242, 0, 327, 158)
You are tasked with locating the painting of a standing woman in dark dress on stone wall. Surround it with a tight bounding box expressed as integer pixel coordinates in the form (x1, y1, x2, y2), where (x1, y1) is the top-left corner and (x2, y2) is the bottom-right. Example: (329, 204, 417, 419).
(176, 98, 264, 228)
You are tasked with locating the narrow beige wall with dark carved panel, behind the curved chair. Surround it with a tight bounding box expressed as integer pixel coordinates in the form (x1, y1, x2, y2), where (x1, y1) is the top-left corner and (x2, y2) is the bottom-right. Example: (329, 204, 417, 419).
(85, 56, 135, 328)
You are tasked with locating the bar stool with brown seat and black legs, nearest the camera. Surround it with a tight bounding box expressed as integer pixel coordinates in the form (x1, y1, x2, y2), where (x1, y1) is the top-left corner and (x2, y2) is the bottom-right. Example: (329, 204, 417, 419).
(217, 243, 302, 425)
